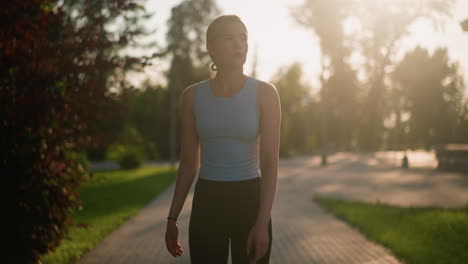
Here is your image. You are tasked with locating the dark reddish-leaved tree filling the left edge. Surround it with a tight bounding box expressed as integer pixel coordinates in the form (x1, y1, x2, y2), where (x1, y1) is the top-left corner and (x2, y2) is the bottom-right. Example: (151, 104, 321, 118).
(0, 0, 155, 263)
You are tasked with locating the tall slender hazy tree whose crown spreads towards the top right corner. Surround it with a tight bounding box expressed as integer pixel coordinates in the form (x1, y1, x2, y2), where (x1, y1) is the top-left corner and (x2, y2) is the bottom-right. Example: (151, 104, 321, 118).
(355, 0, 453, 150)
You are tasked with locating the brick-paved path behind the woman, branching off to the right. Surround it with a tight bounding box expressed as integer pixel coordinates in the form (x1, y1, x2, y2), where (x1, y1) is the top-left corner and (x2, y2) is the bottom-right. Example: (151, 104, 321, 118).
(78, 153, 468, 264)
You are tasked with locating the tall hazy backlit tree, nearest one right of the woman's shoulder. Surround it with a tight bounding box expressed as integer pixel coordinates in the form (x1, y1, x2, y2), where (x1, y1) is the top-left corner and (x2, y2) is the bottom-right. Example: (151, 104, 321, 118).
(294, 0, 358, 154)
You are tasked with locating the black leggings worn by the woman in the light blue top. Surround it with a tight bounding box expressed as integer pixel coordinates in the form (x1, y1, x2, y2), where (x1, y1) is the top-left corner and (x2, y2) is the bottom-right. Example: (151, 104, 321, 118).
(189, 177, 273, 264)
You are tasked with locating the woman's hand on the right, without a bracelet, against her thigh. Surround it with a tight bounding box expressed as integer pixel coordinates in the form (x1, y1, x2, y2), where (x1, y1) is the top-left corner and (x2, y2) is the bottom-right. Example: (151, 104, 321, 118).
(247, 223, 270, 264)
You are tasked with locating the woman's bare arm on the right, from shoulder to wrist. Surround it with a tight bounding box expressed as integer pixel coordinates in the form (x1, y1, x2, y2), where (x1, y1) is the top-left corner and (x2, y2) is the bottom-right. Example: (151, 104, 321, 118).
(256, 82, 281, 225)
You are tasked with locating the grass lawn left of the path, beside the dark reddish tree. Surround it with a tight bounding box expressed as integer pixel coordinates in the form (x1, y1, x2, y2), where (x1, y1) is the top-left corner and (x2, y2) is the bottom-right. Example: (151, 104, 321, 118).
(41, 166, 176, 264)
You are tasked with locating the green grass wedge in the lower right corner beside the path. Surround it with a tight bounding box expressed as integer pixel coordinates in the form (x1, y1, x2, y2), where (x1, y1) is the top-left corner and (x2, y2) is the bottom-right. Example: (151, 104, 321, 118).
(314, 197, 468, 264)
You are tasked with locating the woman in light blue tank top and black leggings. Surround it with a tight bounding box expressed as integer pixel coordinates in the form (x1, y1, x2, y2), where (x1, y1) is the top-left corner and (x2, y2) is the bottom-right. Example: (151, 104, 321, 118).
(166, 15, 281, 264)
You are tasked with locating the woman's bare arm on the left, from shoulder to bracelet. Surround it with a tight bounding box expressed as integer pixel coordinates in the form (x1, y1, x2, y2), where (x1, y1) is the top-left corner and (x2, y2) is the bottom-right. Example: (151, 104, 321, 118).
(169, 85, 200, 217)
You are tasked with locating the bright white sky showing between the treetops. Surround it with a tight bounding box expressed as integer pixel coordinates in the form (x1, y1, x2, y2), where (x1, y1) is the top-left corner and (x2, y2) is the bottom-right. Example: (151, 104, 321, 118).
(140, 0, 468, 95)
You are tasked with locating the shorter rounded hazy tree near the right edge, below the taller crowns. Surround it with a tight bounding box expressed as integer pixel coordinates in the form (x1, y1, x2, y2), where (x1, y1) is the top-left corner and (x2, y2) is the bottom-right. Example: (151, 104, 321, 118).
(392, 47, 464, 149)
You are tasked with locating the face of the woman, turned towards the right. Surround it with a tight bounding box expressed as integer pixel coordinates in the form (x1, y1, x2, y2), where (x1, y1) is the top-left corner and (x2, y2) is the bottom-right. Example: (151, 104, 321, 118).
(208, 21, 248, 68)
